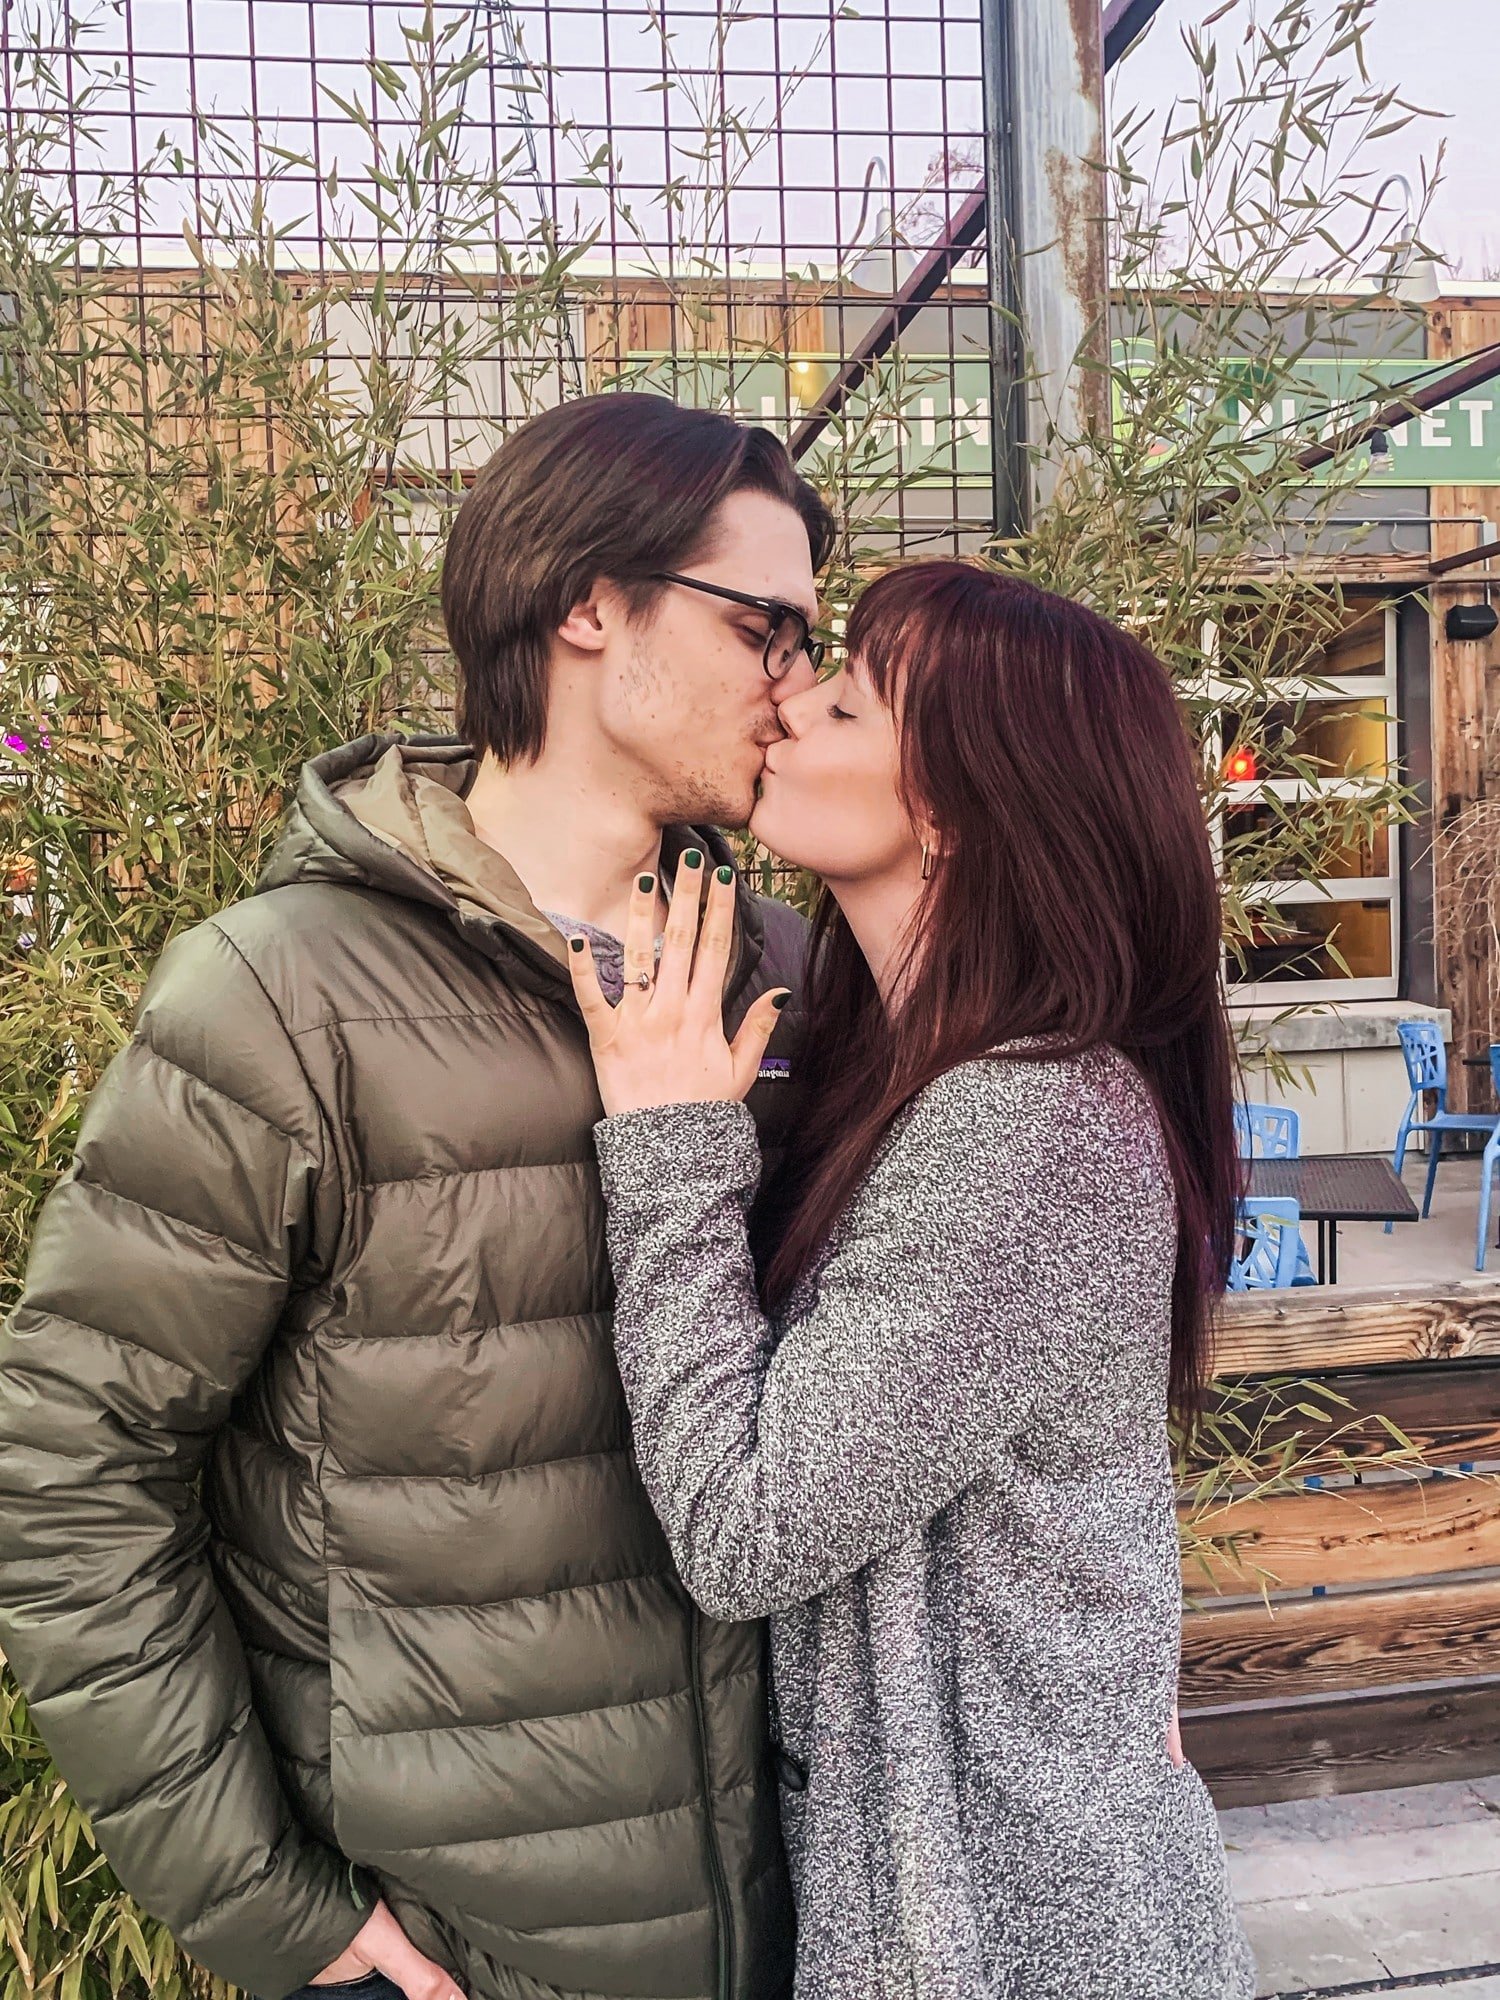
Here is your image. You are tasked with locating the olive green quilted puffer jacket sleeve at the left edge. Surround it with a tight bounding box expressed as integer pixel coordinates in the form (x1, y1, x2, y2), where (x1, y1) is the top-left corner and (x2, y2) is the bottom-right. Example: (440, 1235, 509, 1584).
(0, 922, 368, 2000)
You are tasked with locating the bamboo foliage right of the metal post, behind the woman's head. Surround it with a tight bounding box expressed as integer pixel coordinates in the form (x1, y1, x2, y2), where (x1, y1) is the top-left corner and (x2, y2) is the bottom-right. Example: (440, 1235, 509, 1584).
(994, 0, 1424, 992)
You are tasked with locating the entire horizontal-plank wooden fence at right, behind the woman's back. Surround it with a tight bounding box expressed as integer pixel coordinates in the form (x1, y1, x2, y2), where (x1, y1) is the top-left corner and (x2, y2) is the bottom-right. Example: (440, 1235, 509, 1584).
(1180, 1278, 1500, 1806)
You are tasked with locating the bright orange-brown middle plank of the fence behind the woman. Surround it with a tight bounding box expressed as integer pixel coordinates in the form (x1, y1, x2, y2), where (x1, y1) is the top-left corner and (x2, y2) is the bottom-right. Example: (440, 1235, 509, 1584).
(1182, 1478, 1500, 1600)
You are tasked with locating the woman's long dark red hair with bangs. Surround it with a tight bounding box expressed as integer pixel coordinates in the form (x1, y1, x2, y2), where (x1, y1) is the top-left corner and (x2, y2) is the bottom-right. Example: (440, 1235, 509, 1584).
(756, 562, 1240, 1420)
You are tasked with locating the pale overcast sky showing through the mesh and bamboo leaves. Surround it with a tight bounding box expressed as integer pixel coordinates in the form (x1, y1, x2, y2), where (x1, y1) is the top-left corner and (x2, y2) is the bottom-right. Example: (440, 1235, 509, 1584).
(47, 0, 1500, 278)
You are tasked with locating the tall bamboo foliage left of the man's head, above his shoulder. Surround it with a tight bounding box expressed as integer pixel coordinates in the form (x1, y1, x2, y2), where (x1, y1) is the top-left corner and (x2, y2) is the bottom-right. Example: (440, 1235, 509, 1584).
(0, 0, 576, 1286)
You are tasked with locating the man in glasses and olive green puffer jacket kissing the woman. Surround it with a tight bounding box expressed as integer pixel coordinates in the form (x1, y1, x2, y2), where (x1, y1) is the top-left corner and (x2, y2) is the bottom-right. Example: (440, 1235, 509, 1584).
(0, 396, 832, 2000)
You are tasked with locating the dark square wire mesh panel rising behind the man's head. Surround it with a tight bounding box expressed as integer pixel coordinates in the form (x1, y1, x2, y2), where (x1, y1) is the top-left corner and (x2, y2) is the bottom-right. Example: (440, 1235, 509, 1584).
(0, 0, 1012, 936)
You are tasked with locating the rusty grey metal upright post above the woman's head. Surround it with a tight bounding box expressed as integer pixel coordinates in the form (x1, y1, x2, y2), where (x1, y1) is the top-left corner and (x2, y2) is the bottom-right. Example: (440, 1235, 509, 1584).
(986, 0, 1110, 524)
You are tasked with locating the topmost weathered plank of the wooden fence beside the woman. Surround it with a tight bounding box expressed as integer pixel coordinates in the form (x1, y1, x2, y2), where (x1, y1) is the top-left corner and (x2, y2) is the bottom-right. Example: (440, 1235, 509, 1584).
(1214, 1278, 1500, 1376)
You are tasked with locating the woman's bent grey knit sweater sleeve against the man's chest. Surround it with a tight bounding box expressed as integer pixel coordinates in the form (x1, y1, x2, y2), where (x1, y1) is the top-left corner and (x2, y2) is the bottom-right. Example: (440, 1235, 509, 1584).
(596, 1062, 1086, 1618)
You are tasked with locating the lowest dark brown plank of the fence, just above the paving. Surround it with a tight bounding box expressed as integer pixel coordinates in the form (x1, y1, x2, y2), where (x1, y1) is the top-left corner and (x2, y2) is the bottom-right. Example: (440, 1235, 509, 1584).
(1182, 1676, 1500, 1806)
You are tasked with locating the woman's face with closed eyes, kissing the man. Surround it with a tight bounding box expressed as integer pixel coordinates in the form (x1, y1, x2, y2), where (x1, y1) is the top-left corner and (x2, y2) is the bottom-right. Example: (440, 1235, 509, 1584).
(750, 660, 922, 884)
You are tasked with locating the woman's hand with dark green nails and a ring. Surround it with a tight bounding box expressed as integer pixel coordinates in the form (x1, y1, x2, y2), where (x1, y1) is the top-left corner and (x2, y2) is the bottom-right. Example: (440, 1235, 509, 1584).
(568, 848, 788, 1116)
